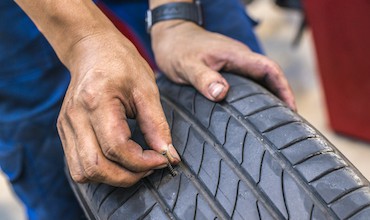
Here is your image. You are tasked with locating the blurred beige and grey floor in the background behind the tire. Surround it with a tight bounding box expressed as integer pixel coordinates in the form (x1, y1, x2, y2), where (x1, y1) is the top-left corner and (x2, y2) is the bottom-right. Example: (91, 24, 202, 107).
(0, 0, 370, 220)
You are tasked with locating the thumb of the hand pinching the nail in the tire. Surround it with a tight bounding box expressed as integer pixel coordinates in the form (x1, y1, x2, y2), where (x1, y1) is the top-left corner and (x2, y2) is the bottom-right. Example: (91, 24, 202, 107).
(135, 86, 181, 164)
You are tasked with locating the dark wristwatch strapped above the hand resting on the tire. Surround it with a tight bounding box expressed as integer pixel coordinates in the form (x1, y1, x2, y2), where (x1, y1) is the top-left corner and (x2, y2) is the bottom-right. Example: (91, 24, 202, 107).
(145, 0, 203, 33)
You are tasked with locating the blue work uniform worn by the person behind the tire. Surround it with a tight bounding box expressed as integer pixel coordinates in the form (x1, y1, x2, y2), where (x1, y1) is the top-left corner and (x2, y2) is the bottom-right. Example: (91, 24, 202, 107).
(0, 0, 261, 220)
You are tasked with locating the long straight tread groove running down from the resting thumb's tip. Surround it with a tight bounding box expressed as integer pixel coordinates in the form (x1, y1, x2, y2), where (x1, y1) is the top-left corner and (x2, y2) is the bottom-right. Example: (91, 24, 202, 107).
(221, 104, 338, 218)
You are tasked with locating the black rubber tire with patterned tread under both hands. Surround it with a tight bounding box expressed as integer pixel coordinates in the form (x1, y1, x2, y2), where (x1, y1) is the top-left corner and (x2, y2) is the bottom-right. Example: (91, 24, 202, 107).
(71, 74, 370, 220)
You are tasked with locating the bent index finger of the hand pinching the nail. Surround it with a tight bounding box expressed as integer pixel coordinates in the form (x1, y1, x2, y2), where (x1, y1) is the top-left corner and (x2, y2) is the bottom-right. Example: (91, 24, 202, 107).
(90, 98, 167, 172)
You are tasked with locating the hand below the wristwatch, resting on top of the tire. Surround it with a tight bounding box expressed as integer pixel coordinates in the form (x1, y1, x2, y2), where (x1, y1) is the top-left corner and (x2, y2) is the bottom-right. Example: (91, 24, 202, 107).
(151, 20, 296, 110)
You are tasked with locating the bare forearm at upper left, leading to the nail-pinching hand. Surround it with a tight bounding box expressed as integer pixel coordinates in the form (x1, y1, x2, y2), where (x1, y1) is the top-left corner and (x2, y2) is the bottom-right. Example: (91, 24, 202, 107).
(15, 0, 125, 67)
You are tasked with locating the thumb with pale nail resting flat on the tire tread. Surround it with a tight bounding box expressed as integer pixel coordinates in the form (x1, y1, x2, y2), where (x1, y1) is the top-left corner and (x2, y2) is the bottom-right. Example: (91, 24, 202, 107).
(187, 64, 229, 102)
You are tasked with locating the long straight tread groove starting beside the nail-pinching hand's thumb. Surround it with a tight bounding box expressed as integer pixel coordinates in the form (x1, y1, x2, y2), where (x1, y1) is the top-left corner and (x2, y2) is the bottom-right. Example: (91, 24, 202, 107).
(161, 94, 283, 219)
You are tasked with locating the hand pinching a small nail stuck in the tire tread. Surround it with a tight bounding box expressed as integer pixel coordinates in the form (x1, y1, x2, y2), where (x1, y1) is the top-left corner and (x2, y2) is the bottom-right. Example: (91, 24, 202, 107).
(57, 31, 180, 187)
